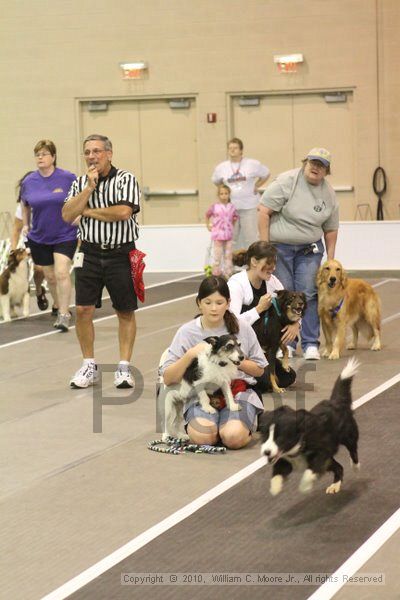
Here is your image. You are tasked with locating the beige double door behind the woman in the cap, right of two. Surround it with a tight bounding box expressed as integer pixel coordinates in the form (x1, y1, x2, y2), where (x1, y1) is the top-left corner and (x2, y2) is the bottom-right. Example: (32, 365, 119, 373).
(232, 92, 356, 220)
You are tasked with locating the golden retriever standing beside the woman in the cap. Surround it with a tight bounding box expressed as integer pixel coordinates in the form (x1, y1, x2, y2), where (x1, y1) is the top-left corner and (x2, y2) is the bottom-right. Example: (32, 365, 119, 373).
(317, 255, 381, 360)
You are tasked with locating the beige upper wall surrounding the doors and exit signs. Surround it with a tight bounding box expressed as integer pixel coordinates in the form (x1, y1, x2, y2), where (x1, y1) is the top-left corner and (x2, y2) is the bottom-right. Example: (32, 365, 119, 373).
(0, 0, 400, 222)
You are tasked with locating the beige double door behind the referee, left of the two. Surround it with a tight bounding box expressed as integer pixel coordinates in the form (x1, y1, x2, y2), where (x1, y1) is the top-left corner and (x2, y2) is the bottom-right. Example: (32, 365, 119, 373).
(81, 99, 200, 225)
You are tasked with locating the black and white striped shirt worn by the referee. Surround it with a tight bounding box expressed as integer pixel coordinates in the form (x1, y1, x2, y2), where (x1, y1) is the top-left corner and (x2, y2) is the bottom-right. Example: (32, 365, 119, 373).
(65, 166, 141, 246)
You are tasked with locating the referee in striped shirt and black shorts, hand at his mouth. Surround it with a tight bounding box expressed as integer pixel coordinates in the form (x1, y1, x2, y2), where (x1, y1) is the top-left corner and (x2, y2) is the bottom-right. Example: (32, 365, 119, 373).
(62, 135, 140, 388)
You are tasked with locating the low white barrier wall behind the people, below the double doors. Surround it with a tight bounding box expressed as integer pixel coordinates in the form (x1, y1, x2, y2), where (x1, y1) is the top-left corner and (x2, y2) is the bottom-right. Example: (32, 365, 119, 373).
(137, 221, 400, 272)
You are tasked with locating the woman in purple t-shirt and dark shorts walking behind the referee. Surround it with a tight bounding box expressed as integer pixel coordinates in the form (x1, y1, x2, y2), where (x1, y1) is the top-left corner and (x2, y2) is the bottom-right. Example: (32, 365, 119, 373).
(21, 140, 77, 331)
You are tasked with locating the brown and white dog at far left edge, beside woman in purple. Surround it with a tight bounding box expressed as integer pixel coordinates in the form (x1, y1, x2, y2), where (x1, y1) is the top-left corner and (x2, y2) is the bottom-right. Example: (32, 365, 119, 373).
(0, 248, 29, 322)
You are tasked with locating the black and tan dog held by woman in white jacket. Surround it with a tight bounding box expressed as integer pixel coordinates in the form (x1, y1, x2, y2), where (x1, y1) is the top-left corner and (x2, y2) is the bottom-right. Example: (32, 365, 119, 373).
(253, 290, 307, 394)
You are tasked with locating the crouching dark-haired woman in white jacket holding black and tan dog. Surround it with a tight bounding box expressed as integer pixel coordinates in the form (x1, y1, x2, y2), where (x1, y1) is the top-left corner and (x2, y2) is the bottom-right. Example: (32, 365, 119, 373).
(228, 242, 299, 391)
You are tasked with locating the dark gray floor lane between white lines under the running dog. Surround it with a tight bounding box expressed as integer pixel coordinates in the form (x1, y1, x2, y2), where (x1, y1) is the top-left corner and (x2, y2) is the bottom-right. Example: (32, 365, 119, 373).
(70, 384, 400, 600)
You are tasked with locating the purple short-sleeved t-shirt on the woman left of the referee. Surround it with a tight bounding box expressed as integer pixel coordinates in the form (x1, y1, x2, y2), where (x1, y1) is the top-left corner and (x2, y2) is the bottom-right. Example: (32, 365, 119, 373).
(21, 168, 77, 244)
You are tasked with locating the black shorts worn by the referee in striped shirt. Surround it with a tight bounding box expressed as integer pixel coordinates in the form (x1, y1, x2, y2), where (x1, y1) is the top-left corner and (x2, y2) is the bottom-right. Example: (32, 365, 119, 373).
(75, 242, 138, 312)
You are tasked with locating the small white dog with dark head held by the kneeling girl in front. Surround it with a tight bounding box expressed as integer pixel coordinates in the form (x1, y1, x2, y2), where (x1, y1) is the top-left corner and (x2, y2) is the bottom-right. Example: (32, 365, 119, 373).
(163, 334, 244, 441)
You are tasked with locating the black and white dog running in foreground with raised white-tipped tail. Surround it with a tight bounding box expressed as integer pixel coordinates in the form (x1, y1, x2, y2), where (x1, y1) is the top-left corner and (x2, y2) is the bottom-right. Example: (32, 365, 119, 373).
(260, 358, 359, 496)
